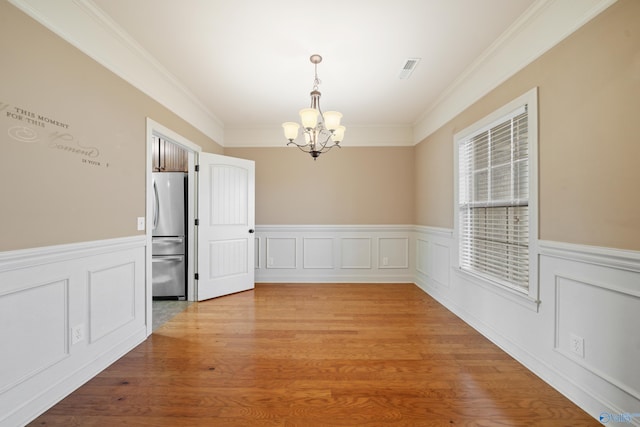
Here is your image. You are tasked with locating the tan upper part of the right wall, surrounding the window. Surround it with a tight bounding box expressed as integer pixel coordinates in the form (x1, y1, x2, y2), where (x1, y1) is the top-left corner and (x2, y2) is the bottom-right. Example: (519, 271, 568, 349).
(416, 0, 640, 250)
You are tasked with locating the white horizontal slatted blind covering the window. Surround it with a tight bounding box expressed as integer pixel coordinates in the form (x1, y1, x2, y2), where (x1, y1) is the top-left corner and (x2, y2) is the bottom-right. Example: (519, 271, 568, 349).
(458, 105, 529, 291)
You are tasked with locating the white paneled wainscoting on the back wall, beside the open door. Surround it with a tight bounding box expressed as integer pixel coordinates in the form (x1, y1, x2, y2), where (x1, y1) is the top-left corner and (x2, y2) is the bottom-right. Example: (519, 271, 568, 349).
(255, 225, 414, 283)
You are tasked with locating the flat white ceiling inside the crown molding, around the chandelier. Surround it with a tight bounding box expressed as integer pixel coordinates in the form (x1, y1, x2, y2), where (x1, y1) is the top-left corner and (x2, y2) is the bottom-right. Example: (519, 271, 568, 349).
(93, 0, 534, 144)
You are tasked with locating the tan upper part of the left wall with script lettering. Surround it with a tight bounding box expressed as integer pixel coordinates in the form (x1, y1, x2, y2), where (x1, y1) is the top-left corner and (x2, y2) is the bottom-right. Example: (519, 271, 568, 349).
(0, 1, 222, 251)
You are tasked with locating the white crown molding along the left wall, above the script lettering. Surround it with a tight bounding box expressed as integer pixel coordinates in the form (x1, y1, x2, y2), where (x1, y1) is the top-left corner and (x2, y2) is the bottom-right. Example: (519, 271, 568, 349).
(9, 0, 224, 145)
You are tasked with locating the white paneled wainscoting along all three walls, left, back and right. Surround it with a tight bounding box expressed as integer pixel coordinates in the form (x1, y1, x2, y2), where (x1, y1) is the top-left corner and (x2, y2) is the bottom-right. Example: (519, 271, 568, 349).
(0, 225, 640, 427)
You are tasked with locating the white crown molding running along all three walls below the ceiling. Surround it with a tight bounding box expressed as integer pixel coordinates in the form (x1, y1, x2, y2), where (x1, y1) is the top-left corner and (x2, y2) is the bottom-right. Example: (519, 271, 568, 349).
(8, 0, 617, 147)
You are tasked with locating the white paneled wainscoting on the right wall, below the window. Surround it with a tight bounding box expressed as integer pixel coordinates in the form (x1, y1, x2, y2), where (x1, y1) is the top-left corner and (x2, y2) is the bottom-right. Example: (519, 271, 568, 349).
(415, 227, 640, 425)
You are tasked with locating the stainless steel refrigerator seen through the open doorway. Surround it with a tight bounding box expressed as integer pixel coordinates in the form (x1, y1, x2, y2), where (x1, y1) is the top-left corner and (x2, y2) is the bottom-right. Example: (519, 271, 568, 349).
(151, 172, 187, 299)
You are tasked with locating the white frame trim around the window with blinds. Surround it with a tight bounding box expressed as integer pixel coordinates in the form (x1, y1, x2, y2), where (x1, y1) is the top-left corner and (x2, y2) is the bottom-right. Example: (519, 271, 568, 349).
(453, 87, 540, 311)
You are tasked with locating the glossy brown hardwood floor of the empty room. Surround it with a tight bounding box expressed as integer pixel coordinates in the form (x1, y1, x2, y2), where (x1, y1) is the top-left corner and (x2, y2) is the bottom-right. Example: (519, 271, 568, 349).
(31, 284, 600, 427)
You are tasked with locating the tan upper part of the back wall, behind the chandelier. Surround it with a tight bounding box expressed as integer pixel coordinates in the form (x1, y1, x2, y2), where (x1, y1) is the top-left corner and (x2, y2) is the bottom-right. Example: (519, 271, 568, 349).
(225, 147, 414, 225)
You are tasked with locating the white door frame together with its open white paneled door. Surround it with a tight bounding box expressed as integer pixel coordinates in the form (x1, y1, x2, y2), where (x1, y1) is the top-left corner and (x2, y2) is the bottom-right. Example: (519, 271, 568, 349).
(145, 118, 256, 335)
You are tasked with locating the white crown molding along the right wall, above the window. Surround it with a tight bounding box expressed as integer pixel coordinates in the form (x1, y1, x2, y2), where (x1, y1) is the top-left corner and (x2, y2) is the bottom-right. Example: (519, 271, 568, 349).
(413, 0, 617, 144)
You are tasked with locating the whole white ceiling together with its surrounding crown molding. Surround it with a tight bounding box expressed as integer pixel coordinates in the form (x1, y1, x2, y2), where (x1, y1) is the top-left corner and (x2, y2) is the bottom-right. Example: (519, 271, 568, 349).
(9, 0, 615, 147)
